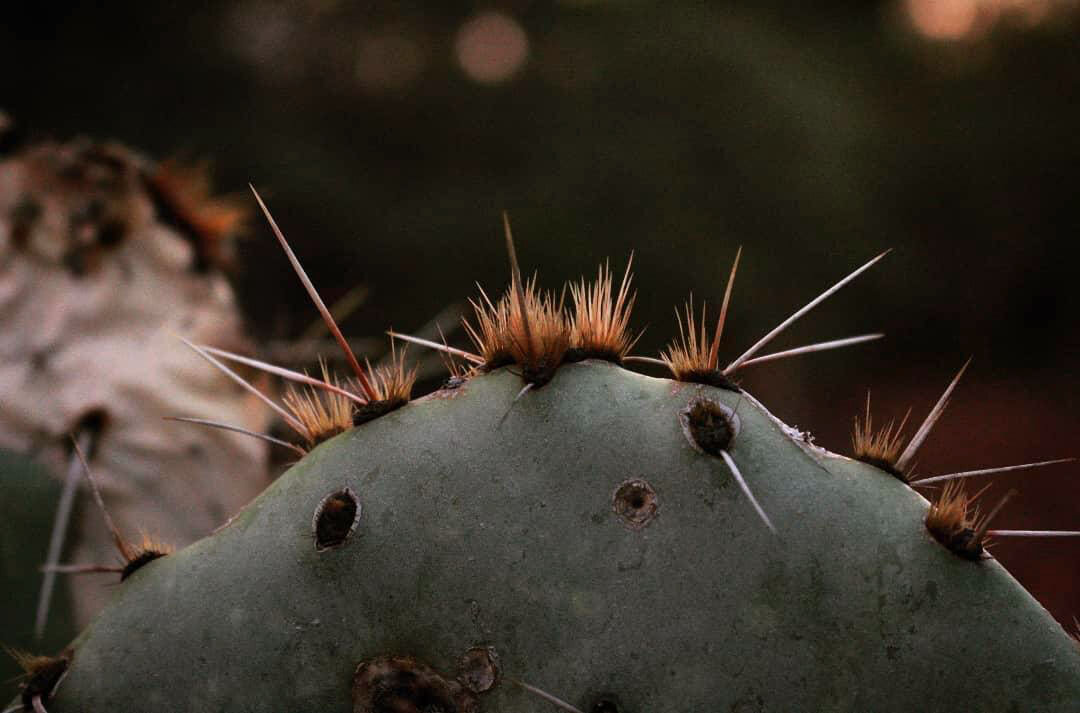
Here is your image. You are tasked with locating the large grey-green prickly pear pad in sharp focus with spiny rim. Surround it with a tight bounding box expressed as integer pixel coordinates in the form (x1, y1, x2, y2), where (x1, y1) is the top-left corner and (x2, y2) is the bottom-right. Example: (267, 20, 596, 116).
(14, 196, 1080, 713)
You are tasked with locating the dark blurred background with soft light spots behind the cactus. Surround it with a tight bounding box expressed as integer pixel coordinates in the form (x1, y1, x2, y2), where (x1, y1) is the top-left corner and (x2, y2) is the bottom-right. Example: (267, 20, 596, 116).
(0, 0, 1080, 691)
